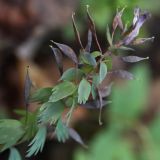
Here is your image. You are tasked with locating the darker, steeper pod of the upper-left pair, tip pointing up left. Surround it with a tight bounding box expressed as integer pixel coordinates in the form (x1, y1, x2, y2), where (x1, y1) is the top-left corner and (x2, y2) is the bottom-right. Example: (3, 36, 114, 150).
(50, 45, 63, 75)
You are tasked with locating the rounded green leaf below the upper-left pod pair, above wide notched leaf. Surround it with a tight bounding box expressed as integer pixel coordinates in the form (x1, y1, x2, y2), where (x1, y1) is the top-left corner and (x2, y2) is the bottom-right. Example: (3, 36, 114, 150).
(61, 68, 84, 81)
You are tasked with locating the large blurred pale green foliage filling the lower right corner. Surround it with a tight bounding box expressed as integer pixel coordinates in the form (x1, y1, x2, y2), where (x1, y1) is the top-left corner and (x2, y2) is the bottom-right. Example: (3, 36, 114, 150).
(75, 66, 160, 160)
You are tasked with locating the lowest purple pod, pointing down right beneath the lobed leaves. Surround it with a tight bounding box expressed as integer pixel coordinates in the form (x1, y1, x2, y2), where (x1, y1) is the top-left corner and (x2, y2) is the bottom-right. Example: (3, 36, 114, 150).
(68, 128, 88, 148)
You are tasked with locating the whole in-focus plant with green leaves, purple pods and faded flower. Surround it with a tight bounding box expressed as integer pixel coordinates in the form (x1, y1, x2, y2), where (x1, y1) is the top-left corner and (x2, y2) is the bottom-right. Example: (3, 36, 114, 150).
(0, 7, 153, 158)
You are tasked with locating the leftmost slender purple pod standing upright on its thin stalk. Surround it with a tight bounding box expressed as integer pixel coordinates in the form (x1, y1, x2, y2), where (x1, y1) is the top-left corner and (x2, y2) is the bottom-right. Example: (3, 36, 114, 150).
(24, 66, 32, 119)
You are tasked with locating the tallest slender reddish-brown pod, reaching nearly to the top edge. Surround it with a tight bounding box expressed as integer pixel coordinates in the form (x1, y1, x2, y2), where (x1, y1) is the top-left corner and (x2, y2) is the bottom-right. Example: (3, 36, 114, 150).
(87, 5, 102, 53)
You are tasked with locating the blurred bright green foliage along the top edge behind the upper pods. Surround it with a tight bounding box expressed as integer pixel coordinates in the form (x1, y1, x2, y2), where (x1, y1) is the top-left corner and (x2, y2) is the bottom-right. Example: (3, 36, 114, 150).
(64, 0, 160, 38)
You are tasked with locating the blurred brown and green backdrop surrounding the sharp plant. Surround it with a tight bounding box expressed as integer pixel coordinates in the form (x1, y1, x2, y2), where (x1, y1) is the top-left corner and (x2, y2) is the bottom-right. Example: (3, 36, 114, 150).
(0, 0, 160, 160)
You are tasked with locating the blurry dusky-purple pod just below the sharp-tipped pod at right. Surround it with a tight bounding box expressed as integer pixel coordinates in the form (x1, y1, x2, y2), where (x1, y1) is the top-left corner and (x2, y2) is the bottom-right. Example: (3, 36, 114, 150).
(111, 70, 134, 80)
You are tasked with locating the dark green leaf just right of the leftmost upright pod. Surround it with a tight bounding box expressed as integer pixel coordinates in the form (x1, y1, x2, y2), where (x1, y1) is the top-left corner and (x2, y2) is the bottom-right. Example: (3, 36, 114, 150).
(30, 87, 53, 103)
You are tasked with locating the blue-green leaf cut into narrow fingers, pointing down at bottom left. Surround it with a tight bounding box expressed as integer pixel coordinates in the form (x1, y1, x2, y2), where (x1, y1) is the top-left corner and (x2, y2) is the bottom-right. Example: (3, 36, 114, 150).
(26, 126, 47, 157)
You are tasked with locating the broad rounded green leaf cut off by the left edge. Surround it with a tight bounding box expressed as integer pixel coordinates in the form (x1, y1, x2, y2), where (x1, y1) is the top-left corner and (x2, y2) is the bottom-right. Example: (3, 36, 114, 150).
(0, 119, 24, 151)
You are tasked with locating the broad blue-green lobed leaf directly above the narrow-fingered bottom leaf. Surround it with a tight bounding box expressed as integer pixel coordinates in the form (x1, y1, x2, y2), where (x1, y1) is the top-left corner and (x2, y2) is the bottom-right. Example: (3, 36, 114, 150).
(39, 101, 64, 124)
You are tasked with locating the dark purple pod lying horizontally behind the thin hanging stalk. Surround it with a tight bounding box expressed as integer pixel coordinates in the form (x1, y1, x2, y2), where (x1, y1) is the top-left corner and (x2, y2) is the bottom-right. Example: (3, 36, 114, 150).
(81, 100, 111, 109)
